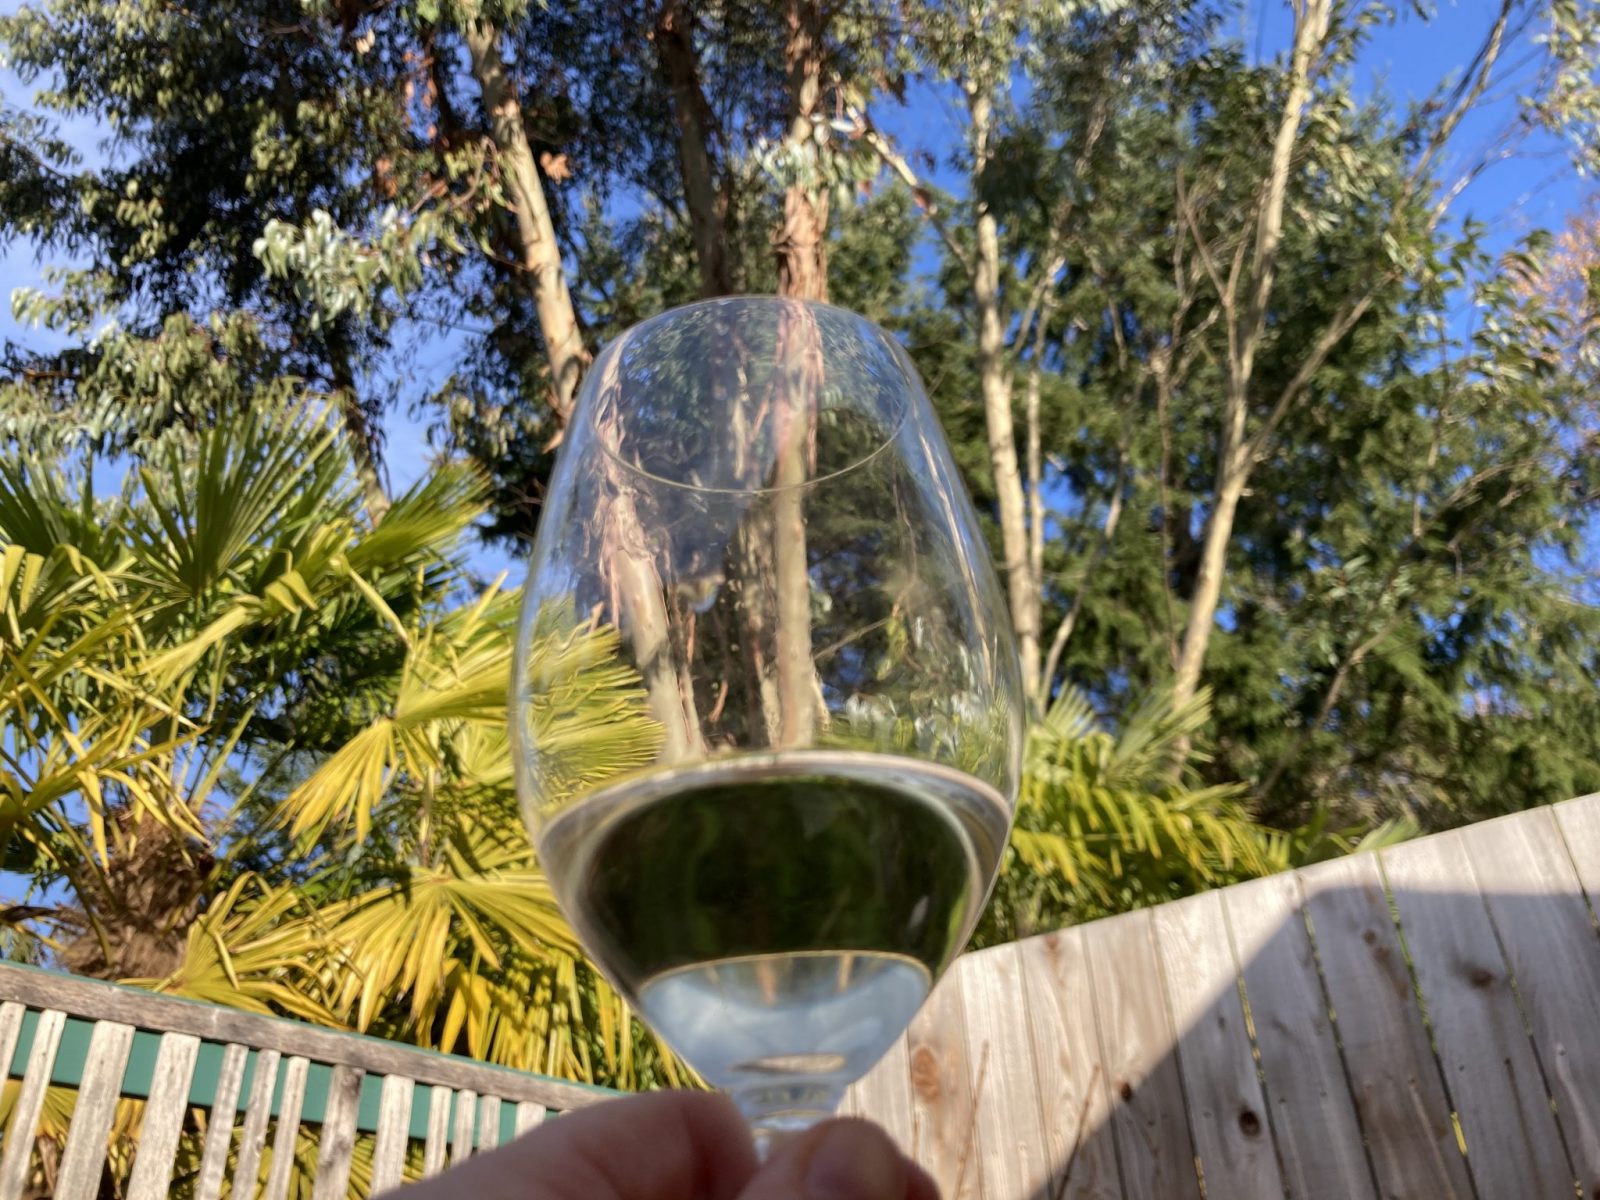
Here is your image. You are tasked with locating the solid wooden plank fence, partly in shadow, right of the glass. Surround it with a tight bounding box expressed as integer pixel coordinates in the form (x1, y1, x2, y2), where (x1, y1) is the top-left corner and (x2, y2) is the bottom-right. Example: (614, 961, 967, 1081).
(848, 795, 1600, 1200)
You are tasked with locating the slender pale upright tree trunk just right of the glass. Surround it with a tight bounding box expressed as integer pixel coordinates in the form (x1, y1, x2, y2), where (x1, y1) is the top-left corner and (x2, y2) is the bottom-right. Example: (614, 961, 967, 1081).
(968, 88, 1040, 704)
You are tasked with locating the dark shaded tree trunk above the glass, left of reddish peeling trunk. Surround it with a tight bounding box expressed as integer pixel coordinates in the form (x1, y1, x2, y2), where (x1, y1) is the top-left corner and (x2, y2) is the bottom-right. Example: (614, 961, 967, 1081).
(656, 0, 733, 296)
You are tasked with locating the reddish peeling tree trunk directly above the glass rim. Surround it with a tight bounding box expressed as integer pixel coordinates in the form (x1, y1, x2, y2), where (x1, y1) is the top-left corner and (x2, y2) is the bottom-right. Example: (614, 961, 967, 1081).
(773, 0, 827, 301)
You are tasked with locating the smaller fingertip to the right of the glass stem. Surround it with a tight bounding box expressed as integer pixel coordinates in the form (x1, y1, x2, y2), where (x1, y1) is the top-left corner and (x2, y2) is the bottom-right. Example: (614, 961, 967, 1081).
(739, 1120, 939, 1200)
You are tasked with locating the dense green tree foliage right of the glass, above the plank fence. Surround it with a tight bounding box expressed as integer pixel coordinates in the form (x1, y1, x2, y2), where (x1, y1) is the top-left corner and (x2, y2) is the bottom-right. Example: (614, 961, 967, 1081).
(902, 6, 1600, 827)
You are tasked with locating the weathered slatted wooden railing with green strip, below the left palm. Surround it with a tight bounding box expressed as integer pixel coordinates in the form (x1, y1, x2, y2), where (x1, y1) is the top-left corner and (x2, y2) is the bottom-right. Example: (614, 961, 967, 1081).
(0, 963, 611, 1200)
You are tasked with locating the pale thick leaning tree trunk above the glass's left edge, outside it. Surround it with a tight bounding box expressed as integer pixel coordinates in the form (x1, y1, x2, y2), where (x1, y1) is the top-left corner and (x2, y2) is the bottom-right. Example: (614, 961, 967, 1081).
(464, 18, 589, 426)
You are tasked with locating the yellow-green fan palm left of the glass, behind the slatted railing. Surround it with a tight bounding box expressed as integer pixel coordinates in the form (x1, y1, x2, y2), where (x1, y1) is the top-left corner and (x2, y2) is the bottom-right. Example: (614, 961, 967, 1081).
(0, 406, 678, 1086)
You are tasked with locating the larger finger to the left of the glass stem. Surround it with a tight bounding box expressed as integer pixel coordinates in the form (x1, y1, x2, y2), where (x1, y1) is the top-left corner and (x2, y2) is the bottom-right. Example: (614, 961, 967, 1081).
(397, 1091, 757, 1200)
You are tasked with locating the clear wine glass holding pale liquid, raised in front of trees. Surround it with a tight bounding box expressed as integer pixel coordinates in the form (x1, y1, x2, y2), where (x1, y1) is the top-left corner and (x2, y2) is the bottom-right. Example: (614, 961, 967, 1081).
(512, 298, 1022, 1146)
